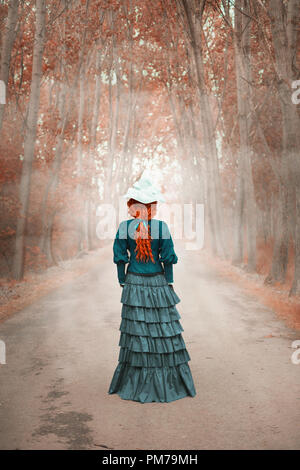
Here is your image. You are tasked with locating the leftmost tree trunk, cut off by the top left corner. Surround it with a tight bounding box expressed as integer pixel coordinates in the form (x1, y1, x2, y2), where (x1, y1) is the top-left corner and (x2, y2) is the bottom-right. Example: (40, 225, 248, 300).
(0, 0, 19, 131)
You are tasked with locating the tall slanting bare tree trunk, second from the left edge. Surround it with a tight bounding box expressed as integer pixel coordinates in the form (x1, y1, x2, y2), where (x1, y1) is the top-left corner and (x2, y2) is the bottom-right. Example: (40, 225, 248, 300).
(12, 0, 46, 280)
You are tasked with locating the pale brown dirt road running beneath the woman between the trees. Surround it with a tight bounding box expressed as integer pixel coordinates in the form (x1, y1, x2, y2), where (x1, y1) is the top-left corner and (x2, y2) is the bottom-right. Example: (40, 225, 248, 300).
(0, 241, 300, 449)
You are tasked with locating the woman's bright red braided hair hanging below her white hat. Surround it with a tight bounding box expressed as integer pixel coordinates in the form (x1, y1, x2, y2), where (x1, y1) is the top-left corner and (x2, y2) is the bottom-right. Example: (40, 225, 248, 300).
(127, 199, 157, 263)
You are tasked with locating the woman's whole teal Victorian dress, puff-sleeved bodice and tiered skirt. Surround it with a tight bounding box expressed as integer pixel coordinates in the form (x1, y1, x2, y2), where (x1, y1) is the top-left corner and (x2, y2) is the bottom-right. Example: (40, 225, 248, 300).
(108, 219, 196, 403)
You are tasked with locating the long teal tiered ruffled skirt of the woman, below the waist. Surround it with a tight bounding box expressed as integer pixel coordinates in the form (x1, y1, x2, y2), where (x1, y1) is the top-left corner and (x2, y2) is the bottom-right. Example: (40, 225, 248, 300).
(108, 272, 196, 403)
